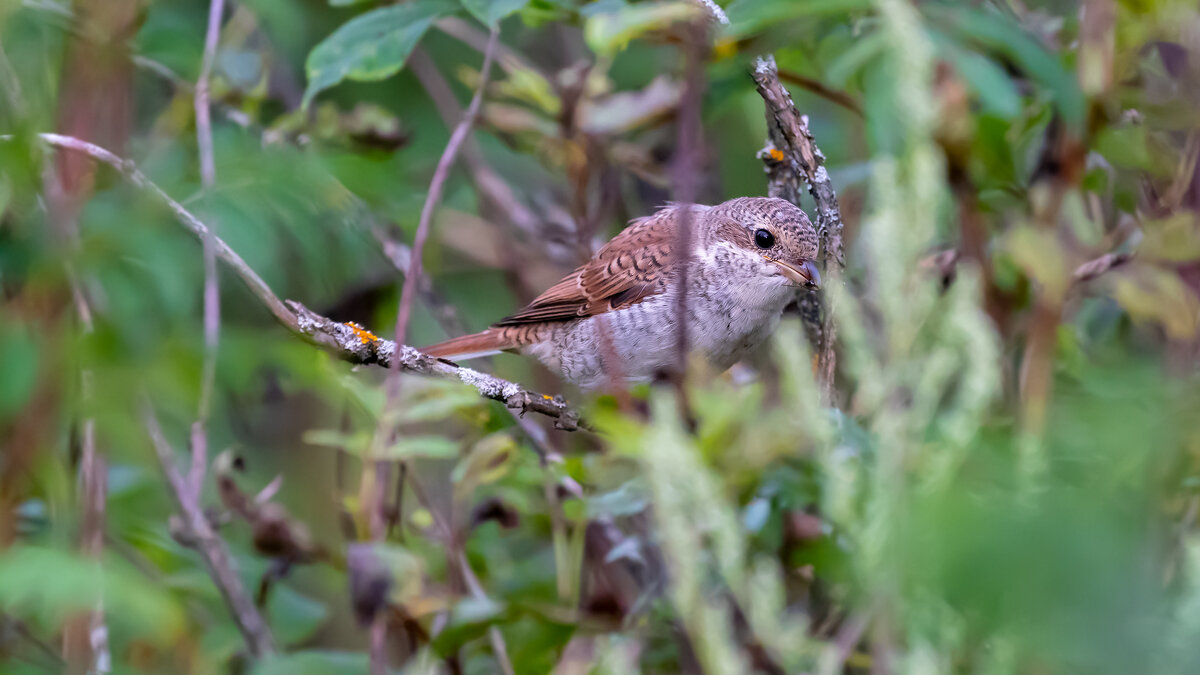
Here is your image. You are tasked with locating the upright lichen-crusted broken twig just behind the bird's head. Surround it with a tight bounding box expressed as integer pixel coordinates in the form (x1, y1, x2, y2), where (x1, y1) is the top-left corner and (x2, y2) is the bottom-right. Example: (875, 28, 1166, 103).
(752, 55, 846, 401)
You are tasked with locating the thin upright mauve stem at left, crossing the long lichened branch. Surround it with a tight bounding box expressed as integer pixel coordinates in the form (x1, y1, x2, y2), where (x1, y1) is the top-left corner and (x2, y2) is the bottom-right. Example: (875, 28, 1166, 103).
(187, 0, 224, 500)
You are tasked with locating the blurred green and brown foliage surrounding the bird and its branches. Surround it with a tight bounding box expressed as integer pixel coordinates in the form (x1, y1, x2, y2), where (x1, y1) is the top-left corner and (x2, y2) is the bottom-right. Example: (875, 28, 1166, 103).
(0, 0, 1200, 674)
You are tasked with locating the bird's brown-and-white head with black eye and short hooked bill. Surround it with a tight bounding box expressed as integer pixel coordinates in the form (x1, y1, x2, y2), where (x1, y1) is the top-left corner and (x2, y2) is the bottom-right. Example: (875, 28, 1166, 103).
(704, 197, 821, 288)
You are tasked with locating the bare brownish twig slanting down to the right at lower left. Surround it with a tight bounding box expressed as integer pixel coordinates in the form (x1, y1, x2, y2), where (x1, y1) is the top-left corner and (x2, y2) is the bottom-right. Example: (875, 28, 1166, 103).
(143, 402, 276, 658)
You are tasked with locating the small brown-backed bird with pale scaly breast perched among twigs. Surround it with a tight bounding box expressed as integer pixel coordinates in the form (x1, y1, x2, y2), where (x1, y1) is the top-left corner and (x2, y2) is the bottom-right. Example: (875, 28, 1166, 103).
(421, 197, 821, 390)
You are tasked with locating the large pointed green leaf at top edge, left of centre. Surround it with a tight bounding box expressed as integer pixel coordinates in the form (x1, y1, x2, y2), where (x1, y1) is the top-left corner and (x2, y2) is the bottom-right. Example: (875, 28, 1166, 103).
(304, 0, 458, 107)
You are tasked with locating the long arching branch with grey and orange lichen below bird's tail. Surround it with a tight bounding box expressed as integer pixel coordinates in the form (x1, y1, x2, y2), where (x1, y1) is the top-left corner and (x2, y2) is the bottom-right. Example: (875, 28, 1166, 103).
(0, 133, 588, 431)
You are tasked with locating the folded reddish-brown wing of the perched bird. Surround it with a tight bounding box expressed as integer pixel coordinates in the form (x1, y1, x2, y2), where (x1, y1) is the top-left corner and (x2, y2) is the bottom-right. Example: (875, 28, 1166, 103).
(496, 207, 702, 325)
